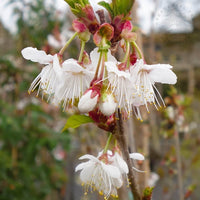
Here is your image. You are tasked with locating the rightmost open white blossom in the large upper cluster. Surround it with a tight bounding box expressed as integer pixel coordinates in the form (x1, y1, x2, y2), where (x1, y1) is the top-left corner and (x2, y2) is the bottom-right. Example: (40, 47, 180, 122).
(130, 59, 177, 118)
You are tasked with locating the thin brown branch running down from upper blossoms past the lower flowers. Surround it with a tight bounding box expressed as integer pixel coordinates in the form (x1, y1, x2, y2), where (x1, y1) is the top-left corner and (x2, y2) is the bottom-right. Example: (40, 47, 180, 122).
(114, 109, 141, 200)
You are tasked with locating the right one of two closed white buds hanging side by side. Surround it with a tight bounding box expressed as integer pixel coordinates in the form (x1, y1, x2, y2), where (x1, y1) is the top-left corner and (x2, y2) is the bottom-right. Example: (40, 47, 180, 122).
(99, 93, 117, 116)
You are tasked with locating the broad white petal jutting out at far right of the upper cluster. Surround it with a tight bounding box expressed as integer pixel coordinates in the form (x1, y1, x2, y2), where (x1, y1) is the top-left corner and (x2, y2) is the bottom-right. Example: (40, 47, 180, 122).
(144, 64, 177, 84)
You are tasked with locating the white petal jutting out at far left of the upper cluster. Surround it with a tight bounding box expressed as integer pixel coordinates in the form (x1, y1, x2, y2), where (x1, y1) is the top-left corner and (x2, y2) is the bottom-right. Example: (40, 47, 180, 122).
(21, 47, 53, 64)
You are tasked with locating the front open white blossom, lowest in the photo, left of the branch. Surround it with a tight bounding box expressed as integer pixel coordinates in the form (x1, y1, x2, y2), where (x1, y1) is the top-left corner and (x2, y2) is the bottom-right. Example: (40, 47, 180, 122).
(75, 154, 123, 199)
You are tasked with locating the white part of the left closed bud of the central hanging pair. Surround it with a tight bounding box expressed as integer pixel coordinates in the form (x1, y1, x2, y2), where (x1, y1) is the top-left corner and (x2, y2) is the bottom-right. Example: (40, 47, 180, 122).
(78, 90, 99, 113)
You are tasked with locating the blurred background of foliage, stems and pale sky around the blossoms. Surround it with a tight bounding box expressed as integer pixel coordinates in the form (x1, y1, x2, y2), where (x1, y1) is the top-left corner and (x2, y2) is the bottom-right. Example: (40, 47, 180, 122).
(0, 0, 200, 200)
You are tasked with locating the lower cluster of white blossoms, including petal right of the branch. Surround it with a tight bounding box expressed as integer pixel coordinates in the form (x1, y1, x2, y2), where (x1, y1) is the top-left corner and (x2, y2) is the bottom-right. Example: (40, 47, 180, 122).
(75, 150, 144, 199)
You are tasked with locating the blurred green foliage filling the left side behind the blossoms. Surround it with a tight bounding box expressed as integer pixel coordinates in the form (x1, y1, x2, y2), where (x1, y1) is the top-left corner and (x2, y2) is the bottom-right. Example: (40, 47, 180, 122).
(0, 0, 70, 200)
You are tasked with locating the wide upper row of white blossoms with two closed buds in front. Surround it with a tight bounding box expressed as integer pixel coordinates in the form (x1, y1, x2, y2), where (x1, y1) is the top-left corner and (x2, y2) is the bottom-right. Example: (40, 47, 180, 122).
(22, 47, 176, 119)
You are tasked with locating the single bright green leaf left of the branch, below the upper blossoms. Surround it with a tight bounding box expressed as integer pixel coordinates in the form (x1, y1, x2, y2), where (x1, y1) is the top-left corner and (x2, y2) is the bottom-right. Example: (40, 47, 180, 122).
(62, 115, 94, 132)
